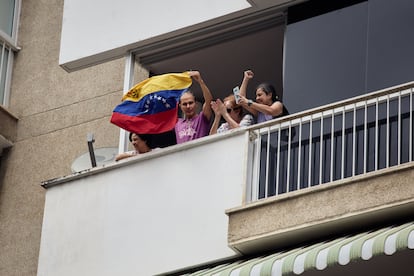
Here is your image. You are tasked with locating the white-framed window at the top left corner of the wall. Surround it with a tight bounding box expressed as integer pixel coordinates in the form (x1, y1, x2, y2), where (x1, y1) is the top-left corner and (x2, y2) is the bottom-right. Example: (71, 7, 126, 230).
(0, 0, 20, 106)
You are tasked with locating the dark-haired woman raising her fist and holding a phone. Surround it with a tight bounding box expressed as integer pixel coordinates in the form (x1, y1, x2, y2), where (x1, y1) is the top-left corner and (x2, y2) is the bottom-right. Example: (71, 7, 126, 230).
(239, 70, 289, 123)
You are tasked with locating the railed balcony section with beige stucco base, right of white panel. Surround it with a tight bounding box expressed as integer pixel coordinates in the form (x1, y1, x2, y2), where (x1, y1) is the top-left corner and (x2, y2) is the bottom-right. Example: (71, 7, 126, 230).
(227, 80, 414, 254)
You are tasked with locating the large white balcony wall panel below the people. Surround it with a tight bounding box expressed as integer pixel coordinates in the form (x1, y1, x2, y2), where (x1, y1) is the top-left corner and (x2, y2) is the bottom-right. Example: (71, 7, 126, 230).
(38, 132, 248, 276)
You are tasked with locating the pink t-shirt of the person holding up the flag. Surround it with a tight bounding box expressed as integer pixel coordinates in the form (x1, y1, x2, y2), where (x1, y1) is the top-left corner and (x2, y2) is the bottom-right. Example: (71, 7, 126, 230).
(175, 112, 210, 144)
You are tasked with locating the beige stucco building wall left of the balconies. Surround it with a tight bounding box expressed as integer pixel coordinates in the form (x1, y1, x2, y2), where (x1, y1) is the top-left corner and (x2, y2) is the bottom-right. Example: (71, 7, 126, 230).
(0, 0, 146, 276)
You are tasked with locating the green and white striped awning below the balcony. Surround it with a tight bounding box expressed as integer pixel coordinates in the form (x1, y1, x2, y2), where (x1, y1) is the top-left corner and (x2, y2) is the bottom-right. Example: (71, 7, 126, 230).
(185, 222, 414, 276)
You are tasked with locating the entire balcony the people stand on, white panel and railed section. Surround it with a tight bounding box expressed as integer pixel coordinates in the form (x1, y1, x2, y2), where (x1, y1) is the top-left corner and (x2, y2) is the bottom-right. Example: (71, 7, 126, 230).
(38, 83, 414, 275)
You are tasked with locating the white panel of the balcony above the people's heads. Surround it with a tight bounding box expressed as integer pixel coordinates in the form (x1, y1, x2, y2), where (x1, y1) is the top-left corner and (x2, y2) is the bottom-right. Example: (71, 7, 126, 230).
(59, 0, 250, 68)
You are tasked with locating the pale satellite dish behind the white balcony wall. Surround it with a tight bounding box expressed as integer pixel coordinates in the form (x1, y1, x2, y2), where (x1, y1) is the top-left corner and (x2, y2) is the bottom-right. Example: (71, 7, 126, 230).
(71, 148, 118, 172)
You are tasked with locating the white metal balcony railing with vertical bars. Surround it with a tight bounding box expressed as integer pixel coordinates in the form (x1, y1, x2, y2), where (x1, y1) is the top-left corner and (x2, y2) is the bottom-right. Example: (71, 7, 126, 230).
(248, 82, 414, 201)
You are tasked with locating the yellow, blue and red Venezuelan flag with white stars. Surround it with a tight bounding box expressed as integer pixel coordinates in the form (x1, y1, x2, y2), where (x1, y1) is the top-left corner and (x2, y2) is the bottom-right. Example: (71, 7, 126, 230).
(111, 72, 192, 134)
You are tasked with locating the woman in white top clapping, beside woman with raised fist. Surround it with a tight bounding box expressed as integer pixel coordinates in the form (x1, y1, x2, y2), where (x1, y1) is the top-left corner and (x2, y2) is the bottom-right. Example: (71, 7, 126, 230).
(210, 95, 253, 134)
